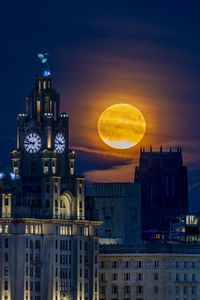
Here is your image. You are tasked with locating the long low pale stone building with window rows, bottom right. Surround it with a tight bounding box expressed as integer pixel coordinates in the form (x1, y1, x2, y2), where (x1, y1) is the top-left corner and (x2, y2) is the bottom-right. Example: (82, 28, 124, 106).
(99, 244, 200, 300)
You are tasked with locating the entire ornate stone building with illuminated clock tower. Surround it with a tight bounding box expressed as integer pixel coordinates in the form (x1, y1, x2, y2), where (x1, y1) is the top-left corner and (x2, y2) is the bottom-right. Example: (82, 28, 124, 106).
(0, 59, 100, 300)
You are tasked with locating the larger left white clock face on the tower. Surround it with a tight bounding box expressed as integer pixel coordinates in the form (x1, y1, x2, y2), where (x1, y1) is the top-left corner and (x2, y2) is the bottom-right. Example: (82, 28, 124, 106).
(24, 132, 42, 154)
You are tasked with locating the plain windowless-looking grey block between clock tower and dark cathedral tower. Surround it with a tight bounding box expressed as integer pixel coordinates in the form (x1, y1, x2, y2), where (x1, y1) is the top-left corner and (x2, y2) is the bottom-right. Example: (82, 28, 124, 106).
(93, 183, 141, 245)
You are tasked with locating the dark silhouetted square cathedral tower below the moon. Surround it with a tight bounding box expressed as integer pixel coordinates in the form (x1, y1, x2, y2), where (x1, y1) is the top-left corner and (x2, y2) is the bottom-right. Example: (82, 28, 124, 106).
(135, 147, 188, 240)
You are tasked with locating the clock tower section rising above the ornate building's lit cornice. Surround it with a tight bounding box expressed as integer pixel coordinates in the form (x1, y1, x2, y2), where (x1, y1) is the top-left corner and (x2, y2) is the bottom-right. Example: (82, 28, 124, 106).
(11, 60, 84, 219)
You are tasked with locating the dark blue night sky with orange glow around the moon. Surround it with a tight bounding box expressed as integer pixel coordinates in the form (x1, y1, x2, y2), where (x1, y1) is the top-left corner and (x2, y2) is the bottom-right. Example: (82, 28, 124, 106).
(0, 0, 200, 211)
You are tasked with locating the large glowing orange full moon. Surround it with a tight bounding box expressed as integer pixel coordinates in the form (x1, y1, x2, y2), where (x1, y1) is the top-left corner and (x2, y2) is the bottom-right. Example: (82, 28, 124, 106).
(97, 103, 146, 149)
